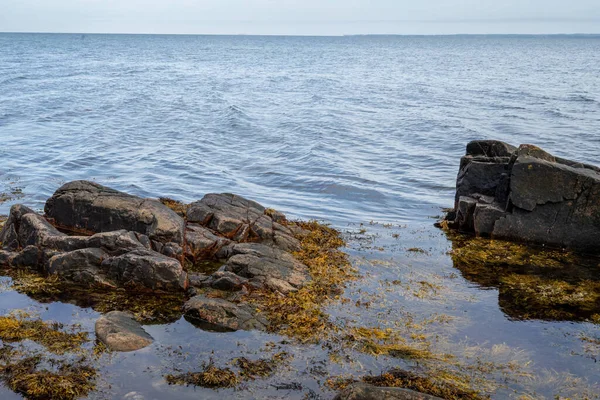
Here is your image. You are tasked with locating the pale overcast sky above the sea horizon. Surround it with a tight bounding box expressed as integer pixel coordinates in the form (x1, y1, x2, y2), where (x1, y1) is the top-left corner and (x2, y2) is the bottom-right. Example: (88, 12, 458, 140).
(0, 0, 600, 35)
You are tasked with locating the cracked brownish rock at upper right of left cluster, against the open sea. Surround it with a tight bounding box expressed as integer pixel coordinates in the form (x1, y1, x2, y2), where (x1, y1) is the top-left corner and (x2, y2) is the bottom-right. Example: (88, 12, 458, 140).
(187, 193, 300, 250)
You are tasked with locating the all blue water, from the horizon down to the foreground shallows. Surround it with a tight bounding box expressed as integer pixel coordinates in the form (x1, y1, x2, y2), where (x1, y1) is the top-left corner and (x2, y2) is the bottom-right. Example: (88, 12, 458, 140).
(0, 34, 600, 400)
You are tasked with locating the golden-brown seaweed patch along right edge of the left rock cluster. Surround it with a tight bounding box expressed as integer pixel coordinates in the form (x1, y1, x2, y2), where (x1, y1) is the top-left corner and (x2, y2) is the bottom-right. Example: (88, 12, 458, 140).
(247, 221, 357, 342)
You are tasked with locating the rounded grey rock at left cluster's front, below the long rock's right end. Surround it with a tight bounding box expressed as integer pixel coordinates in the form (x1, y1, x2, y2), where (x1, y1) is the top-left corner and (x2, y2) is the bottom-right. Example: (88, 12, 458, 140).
(101, 249, 188, 291)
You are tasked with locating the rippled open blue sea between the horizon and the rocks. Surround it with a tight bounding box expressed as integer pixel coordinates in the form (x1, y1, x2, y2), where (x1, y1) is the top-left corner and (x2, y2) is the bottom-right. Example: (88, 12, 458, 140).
(0, 34, 600, 223)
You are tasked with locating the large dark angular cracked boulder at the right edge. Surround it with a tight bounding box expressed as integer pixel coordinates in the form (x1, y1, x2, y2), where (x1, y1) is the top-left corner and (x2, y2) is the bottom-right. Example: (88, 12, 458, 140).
(442, 141, 600, 253)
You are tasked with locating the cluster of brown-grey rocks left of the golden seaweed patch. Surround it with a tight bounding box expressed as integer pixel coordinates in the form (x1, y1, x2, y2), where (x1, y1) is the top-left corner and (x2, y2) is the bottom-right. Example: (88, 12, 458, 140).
(0, 181, 311, 331)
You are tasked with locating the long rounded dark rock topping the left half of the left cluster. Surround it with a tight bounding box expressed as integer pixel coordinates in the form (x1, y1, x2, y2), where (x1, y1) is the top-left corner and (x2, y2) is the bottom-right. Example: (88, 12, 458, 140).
(45, 181, 185, 244)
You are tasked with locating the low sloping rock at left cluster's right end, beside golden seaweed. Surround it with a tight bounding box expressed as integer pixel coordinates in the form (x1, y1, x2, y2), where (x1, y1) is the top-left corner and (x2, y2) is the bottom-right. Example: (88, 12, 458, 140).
(219, 243, 311, 288)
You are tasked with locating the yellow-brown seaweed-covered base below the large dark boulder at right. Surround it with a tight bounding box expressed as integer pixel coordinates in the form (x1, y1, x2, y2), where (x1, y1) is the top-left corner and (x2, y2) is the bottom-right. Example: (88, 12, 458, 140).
(448, 233, 600, 321)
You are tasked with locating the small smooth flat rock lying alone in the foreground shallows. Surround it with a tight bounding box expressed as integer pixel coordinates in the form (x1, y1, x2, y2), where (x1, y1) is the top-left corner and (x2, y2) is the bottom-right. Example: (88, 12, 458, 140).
(96, 311, 154, 352)
